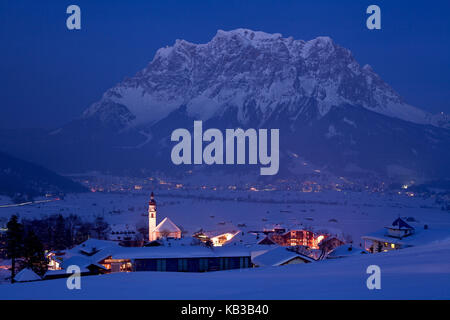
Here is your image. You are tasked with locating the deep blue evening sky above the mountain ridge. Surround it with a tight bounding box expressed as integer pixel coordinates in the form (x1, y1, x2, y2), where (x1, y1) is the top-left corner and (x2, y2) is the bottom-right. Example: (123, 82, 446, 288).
(0, 0, 450, 128)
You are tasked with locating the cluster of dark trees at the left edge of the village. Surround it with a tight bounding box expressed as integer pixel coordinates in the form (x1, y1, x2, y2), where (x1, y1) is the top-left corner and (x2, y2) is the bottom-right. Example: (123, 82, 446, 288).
(2, 214, 109, 282)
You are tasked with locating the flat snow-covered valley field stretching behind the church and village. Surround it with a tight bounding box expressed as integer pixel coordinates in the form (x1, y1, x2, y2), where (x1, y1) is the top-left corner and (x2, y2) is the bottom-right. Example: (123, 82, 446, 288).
(0, 191, 450, 245)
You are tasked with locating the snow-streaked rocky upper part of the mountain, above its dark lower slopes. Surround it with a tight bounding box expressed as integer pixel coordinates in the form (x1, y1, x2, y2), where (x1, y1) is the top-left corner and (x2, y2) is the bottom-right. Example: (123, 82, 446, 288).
(83, 29, 444, 127)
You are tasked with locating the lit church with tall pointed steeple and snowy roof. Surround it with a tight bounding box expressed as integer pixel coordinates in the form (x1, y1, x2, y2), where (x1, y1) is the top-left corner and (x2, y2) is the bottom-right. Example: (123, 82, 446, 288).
(148, 192, 181, 241)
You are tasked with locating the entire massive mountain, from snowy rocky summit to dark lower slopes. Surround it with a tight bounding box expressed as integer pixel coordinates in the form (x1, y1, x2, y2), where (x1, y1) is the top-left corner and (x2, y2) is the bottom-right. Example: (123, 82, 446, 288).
(0, 29, 450, 178)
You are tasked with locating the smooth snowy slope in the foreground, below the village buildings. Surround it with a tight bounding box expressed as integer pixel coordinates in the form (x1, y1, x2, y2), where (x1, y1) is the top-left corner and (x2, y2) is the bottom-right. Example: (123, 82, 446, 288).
(0, 239, 450, 299)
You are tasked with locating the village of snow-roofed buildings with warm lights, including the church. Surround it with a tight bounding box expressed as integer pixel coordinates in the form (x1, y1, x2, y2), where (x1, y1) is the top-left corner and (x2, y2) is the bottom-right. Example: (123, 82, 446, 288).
(1, 192, 449, 282)
